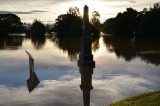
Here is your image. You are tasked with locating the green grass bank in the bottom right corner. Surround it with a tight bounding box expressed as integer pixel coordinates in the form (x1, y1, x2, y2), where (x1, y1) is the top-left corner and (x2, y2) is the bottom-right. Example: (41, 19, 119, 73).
(109, 91, 160, 106)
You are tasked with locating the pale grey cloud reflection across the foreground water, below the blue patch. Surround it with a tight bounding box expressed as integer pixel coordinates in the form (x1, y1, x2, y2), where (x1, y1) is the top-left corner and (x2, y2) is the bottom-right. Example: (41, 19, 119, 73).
(0, 75, 158, 106)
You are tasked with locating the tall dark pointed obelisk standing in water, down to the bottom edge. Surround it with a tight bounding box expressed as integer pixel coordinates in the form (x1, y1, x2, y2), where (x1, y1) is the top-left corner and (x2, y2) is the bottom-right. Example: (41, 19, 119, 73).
(78, 5, 95, 106)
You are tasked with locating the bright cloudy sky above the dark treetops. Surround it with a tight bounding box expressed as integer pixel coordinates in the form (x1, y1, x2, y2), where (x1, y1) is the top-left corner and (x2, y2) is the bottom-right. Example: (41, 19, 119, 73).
(0, 0, 160, 23)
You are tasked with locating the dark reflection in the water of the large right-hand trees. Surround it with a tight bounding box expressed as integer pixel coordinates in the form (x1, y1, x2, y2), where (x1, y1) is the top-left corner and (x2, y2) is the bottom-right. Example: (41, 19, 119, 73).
(104, 37, 160, 65)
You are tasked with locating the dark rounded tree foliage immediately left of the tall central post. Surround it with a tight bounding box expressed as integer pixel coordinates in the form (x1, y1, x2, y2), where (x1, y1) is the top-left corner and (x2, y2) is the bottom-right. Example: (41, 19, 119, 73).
(53, 14, 82, 36)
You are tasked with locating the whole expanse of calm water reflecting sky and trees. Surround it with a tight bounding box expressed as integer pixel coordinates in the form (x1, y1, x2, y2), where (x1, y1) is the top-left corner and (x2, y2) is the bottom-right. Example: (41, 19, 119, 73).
(0, 36, 160, 106)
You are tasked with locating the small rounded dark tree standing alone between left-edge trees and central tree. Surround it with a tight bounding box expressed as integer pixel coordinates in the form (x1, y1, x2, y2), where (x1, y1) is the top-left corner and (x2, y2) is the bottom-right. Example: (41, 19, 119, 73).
(30, 20, 46, 36)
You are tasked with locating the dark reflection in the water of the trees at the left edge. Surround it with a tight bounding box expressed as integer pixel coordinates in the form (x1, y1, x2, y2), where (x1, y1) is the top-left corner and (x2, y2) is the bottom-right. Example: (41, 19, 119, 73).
(0, 36, 24, 49)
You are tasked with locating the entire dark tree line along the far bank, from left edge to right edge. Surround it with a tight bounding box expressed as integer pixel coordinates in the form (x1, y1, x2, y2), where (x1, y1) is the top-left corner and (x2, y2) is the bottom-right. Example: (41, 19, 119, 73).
(0, 3, 160, 37)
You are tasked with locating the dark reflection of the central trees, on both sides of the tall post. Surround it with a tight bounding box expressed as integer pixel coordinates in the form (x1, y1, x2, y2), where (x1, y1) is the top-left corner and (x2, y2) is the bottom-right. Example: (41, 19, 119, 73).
(50, 36, 99, 61)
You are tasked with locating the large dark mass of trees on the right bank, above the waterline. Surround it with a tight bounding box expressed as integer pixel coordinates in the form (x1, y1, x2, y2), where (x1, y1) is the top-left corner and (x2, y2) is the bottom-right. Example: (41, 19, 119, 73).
(103, 3, 160, 37)
